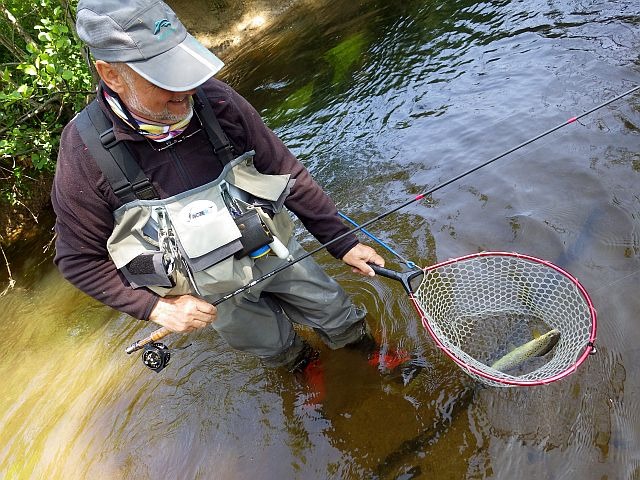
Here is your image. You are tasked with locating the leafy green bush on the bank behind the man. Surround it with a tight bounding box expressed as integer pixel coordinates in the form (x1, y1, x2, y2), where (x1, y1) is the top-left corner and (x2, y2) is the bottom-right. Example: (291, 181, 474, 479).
(0, 0, 95, 224)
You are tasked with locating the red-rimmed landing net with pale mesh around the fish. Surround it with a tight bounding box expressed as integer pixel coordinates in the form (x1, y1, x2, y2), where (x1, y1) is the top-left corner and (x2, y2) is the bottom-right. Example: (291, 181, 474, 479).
(412, 252, 596, 387)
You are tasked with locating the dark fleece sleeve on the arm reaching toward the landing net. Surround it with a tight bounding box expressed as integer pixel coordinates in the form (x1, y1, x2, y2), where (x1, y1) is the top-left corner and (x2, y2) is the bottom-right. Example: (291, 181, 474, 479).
(214, 80, 358, 258)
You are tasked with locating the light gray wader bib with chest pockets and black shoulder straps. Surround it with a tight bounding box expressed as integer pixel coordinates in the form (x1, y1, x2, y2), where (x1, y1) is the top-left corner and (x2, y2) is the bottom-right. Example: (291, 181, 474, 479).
(76, 89, 294, 296)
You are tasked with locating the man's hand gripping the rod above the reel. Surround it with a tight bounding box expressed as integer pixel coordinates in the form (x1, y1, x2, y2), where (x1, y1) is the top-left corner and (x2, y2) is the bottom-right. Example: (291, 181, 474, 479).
(149, 295, 217, 333)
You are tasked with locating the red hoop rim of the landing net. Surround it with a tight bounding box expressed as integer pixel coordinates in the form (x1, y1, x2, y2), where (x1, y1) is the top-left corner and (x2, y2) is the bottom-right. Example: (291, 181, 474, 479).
(418, 252, 597, 386)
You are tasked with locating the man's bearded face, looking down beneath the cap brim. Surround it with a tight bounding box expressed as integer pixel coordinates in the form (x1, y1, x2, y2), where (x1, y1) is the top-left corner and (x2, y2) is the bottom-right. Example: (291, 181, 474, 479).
(117, 67, 195, 125)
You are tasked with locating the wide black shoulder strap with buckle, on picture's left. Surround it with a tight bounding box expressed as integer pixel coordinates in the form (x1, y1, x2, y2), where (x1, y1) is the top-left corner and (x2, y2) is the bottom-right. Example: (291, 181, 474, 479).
(76, 100, 158, 203)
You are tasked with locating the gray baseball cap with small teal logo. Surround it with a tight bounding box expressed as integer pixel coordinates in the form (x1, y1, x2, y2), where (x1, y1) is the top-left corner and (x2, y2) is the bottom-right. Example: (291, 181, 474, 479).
(76, 0, 224, 92)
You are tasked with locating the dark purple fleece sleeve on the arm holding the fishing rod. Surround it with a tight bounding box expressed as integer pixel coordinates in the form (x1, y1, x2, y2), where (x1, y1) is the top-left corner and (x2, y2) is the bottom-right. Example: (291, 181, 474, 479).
(51, 122, 158, 319)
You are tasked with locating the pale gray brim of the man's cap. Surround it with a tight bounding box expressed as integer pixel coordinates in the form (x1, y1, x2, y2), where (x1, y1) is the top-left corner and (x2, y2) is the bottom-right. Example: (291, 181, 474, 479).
(127, 34, 224, 92)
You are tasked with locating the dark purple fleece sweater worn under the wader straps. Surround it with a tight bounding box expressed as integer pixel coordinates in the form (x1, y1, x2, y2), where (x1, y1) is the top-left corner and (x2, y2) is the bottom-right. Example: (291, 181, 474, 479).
(51, 79, 358, 319)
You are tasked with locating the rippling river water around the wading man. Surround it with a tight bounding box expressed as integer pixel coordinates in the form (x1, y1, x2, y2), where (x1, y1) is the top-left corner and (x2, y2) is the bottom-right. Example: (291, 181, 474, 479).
(0, 0, 640, 480)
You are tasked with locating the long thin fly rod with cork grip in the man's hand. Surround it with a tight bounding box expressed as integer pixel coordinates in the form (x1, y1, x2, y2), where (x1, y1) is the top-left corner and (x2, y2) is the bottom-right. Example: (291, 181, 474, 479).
(125, 85, 640, 354)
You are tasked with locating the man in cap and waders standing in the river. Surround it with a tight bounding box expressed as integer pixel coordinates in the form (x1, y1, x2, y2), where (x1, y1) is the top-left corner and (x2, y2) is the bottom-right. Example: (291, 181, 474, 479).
(51, 0, 384, 370)
